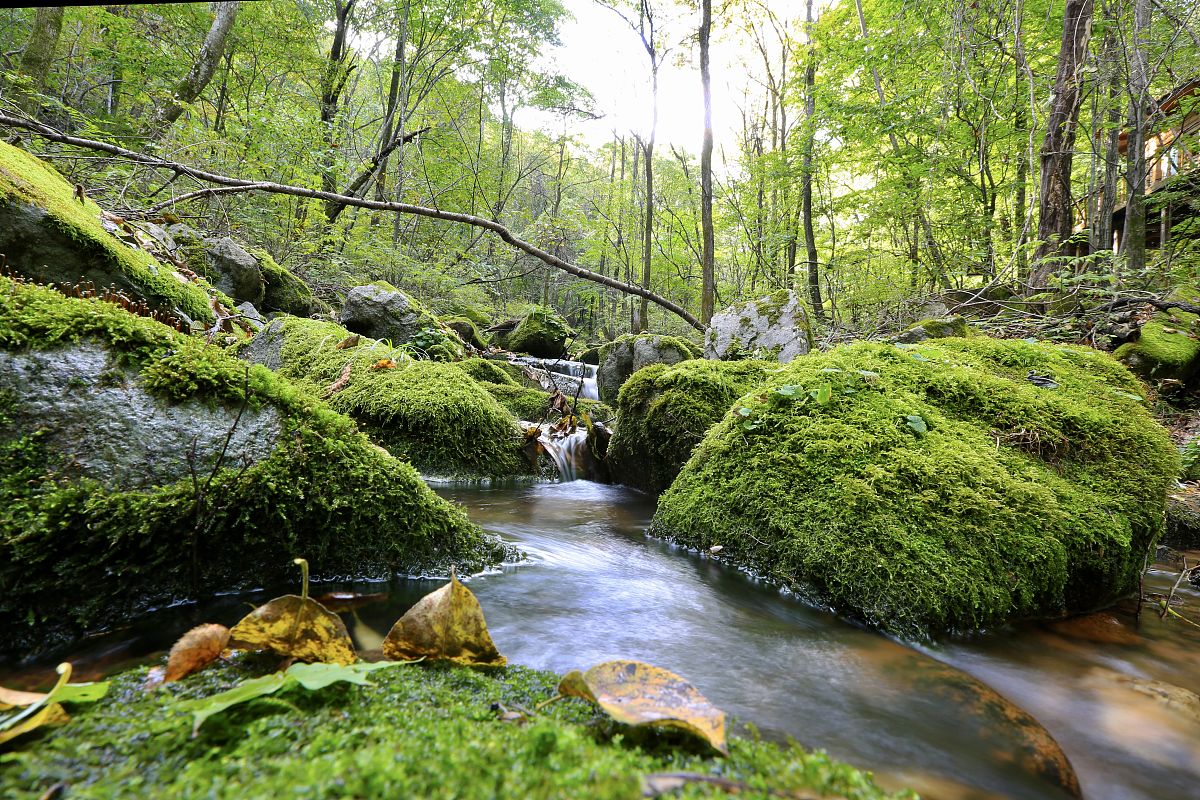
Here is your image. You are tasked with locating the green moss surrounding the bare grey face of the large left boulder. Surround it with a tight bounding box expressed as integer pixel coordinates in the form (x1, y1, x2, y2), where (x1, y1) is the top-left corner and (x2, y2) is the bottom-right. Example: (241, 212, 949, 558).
(0, 279, 504, 655)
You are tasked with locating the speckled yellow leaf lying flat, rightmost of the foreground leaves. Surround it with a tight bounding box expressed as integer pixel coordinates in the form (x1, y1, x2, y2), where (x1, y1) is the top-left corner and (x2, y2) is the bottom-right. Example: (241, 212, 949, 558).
(558, 661, 728, 756)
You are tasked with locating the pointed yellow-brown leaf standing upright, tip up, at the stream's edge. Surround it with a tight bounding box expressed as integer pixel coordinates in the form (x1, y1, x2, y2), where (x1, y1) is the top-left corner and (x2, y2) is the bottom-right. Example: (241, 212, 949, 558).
(383, 570, 508, 667)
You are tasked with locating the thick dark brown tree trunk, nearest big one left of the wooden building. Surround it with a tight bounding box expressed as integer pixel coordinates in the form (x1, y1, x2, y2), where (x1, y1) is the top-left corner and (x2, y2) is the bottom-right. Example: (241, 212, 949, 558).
(1030, 0, 1093, 289)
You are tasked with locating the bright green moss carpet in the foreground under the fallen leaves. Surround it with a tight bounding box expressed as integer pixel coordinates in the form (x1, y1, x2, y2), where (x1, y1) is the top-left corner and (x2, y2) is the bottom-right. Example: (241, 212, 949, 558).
(0, 660, 913, 800)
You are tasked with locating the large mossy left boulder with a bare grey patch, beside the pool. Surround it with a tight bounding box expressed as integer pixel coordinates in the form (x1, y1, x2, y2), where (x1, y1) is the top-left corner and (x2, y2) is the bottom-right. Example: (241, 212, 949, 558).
(0, 278, 504, 656)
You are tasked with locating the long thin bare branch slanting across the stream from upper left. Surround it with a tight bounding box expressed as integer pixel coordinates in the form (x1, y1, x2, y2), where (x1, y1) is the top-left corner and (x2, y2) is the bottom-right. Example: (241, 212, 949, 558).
(0, 114, 704, 331)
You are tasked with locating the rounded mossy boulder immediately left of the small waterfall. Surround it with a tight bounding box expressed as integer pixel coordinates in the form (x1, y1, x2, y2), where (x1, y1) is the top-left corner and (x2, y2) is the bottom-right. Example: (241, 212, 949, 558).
(241, 317, 530, 477)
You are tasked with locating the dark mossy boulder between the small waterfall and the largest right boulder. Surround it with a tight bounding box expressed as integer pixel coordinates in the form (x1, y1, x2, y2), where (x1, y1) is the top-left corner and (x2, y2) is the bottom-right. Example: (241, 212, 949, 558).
(606, 359, 779, 494)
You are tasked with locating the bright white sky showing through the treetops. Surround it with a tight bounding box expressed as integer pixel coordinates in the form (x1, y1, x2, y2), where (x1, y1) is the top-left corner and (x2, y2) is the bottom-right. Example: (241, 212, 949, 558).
(520, 0, 823, 160)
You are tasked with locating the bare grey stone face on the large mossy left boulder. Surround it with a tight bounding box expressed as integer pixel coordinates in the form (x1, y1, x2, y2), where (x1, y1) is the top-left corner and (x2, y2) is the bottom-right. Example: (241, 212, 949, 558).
(0, 342, 281, 489)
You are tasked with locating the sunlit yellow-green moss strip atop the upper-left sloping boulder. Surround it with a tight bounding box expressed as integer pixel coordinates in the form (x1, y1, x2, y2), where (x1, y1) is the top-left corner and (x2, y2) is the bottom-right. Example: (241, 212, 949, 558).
(0, 143, 220, 321)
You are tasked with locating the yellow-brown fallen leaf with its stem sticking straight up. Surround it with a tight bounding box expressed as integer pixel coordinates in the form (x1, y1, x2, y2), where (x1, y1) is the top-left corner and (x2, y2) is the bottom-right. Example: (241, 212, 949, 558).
(229, 559, 358, 664)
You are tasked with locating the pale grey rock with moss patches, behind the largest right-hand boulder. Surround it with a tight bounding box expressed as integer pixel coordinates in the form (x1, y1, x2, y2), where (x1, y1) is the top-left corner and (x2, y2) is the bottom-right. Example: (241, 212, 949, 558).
(704, 289, 812, 363)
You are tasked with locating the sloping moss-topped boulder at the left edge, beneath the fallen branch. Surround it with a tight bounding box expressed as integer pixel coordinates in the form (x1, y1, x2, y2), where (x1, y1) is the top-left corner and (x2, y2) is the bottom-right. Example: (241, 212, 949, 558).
(0, 142, 218, 323)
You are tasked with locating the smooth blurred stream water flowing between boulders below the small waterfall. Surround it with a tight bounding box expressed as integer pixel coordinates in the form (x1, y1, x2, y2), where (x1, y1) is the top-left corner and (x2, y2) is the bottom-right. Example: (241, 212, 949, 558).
(0, 481, 1200, 800)
